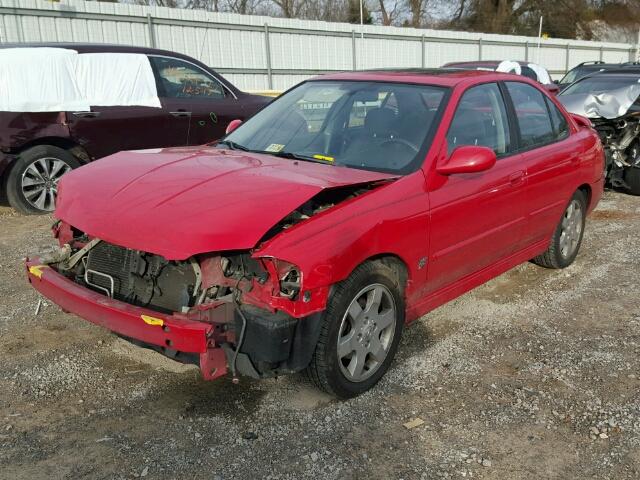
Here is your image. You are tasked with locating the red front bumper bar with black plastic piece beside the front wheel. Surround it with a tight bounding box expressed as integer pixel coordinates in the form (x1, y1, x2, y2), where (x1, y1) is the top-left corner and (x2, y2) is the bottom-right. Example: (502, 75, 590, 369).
(25, 257, 320, 380)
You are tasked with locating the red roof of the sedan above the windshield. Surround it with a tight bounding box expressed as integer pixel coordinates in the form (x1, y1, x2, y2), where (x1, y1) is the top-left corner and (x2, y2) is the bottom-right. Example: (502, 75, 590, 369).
(311, 68, 536, 87)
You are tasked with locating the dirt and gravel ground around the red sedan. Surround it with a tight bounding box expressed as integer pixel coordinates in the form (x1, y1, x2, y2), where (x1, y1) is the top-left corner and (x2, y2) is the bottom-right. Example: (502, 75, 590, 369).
(0, 192, 640, 480)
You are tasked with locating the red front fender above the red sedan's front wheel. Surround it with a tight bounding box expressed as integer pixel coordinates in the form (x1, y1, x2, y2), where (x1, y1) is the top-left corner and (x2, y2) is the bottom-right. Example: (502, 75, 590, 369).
(253, 171, 429, 306)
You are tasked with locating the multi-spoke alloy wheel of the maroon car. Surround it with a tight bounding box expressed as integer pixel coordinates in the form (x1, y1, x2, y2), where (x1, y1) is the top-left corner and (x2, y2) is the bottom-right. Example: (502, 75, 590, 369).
(7, 145, 80, 214)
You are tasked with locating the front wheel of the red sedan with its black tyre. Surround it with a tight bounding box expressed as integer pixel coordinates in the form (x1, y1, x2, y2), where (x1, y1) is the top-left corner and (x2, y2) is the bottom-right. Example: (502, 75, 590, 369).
(306, 261, 405, 398)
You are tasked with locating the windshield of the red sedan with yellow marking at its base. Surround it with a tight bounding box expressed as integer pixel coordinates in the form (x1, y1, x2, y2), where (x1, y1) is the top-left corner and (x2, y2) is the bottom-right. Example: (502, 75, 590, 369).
(218, 81, 447, 174)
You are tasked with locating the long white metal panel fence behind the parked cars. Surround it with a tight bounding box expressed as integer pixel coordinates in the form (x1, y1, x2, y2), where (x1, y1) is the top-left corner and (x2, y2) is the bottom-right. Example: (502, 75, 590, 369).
(0, 0, 638, 90)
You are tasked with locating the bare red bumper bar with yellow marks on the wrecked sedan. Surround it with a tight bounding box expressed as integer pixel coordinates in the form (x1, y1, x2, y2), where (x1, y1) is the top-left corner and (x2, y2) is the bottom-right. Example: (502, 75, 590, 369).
(26, 258, 227, 380)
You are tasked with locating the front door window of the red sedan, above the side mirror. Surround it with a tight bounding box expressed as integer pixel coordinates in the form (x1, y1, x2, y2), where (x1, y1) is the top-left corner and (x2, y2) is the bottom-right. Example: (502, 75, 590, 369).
(447, 83, 510, 156)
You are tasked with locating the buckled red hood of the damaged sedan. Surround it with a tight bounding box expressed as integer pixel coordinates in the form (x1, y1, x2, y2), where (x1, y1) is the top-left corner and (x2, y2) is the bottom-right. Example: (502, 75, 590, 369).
(55, 147, 393, 260)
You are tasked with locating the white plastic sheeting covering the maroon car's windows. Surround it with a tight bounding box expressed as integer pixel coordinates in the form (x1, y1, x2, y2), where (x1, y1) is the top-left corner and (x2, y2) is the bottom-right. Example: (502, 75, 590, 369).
(0, 47, 161, 112)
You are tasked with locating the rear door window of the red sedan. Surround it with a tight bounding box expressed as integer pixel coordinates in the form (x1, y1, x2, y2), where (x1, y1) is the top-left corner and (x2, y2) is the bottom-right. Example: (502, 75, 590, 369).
(505, 82, 556, 149)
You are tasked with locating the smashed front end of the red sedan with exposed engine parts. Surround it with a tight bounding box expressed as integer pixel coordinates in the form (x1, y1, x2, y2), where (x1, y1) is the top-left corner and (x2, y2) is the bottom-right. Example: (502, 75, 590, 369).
(27, 176, 390, 380)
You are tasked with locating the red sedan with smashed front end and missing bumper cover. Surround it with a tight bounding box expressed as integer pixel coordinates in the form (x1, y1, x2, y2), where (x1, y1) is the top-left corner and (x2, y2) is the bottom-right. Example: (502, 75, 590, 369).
(27, 70, 604, 398)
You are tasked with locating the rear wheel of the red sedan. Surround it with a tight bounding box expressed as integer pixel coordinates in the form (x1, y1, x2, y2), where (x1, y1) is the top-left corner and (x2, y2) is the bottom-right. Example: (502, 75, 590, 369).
(533, 190, 587, 268)
